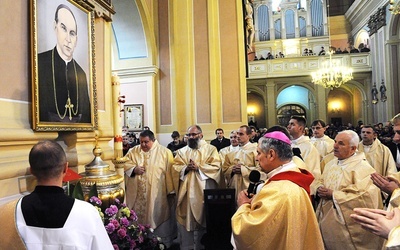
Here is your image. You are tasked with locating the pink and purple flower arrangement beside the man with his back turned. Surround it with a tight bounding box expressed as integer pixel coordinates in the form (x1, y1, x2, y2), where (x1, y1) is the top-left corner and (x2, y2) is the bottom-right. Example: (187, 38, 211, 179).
(89, 196, 166, 250)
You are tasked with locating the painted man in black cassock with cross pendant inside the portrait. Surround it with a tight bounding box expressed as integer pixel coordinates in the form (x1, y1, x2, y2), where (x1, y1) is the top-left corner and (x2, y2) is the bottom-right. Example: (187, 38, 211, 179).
(38, 4, 91, 123)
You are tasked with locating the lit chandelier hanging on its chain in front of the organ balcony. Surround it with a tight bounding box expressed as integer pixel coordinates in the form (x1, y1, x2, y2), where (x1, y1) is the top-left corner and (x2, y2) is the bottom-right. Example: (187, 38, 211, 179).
(311, 1, 353, 89)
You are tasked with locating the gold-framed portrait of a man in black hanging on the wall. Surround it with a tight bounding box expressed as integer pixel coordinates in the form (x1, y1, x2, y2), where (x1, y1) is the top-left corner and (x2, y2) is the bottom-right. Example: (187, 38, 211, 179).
(30, 0, 97, 131)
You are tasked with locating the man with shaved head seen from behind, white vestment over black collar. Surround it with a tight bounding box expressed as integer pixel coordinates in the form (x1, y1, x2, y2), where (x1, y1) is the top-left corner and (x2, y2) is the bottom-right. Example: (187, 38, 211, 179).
(0, 141, 113, 250)
